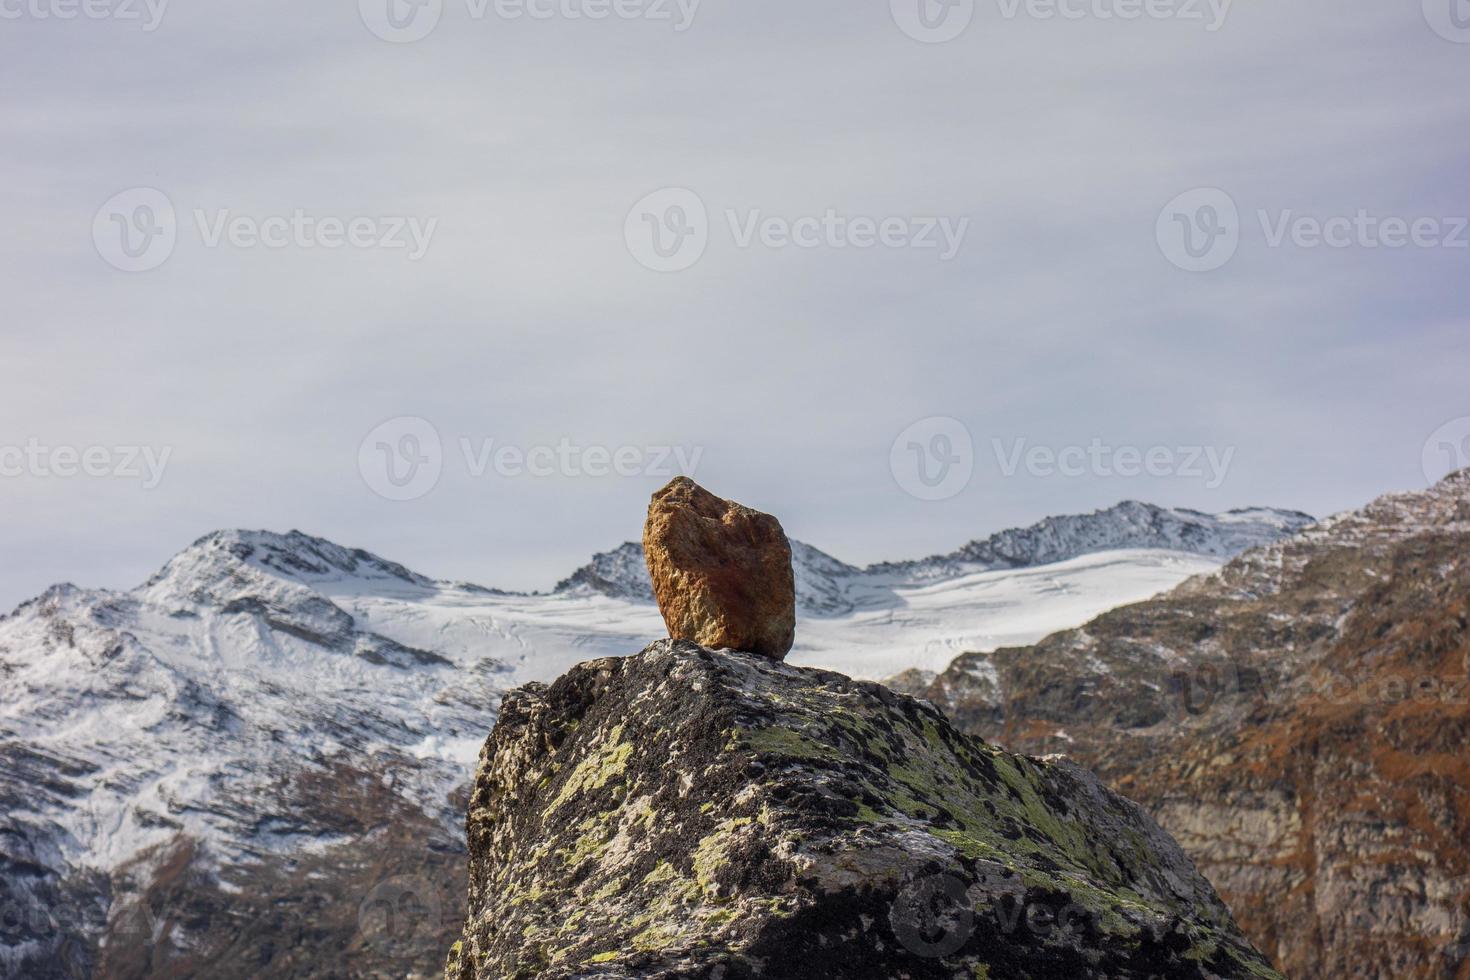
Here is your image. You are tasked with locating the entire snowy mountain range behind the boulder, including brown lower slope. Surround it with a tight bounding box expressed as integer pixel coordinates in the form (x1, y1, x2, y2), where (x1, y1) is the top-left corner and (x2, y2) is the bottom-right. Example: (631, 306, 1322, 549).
(0, 504, 1308, 977)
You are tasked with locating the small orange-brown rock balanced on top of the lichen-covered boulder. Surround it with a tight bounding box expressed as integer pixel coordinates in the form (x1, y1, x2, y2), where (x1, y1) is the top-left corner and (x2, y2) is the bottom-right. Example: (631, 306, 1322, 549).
(644, 476, 797, 660)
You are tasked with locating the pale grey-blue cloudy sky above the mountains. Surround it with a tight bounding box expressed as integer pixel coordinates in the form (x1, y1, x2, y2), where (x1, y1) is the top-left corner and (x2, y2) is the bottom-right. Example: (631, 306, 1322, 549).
(0, 0, 1470, 608)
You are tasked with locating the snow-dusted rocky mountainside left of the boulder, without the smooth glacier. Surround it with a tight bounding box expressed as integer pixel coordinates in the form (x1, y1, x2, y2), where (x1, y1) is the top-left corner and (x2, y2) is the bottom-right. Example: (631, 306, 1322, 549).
(0, 533, 502, 977)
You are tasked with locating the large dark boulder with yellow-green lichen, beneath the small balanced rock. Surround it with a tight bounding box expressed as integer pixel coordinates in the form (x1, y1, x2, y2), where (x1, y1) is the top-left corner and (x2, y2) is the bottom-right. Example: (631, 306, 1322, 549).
(447, 641, 1279, 980)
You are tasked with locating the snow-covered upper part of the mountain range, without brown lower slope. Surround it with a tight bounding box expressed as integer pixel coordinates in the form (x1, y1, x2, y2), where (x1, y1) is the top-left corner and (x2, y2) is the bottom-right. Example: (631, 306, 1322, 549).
(0, 508, 1295, 974)
